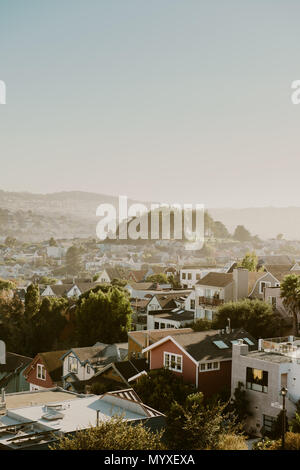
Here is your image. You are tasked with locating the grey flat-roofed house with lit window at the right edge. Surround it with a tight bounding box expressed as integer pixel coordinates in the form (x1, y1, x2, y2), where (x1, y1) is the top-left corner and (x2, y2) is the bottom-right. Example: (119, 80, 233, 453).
(231, 336, 300, 436)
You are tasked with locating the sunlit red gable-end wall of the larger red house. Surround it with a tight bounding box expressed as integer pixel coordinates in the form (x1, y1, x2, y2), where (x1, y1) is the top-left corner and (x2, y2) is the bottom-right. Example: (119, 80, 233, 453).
(150, 340, 196, 385)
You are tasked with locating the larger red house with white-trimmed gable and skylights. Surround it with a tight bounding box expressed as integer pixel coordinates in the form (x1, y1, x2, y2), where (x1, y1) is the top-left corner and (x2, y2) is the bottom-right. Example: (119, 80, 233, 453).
(143, 328, 257, 396)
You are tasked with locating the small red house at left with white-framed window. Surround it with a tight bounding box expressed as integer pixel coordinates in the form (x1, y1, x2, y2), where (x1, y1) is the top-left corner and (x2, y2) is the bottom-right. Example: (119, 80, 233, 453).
(24, 351, 67, 391)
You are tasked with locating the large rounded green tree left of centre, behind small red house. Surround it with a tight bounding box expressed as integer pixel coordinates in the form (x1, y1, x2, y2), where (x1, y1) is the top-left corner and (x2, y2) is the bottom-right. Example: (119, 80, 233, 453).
(76, 285, 132, 346)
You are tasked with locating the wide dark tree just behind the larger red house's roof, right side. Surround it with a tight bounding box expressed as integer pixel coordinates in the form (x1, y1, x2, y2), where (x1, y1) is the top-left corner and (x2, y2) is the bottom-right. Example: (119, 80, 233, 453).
(213, 299, 285, 338)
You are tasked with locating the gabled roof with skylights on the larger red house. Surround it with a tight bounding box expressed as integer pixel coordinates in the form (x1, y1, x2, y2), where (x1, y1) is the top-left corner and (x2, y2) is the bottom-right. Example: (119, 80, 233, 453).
(143, 328, 258, 362)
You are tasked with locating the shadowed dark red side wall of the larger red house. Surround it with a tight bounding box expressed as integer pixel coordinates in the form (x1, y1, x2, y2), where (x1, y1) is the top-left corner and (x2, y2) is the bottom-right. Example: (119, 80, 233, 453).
(198, 360, 231, 396)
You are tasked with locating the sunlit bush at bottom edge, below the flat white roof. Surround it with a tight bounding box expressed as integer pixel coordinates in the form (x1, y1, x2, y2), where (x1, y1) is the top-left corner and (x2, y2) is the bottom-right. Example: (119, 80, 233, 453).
(51, 417, 165, 450)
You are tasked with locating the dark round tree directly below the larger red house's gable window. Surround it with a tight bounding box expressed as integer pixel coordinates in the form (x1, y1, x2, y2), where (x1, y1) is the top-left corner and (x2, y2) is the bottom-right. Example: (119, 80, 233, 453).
(134, 369, 192, 413)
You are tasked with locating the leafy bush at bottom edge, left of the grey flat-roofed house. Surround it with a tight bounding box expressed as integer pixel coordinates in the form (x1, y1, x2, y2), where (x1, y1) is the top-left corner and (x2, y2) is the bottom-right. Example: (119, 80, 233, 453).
(166, 393, 240, 450)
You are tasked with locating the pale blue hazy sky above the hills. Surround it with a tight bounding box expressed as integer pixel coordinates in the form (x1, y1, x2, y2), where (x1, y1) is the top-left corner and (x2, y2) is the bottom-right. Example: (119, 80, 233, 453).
(0, 0, 300, 207)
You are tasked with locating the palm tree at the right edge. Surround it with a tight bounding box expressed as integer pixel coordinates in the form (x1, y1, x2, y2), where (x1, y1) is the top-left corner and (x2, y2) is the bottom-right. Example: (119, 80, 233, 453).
(280, 274, 300, 336)
